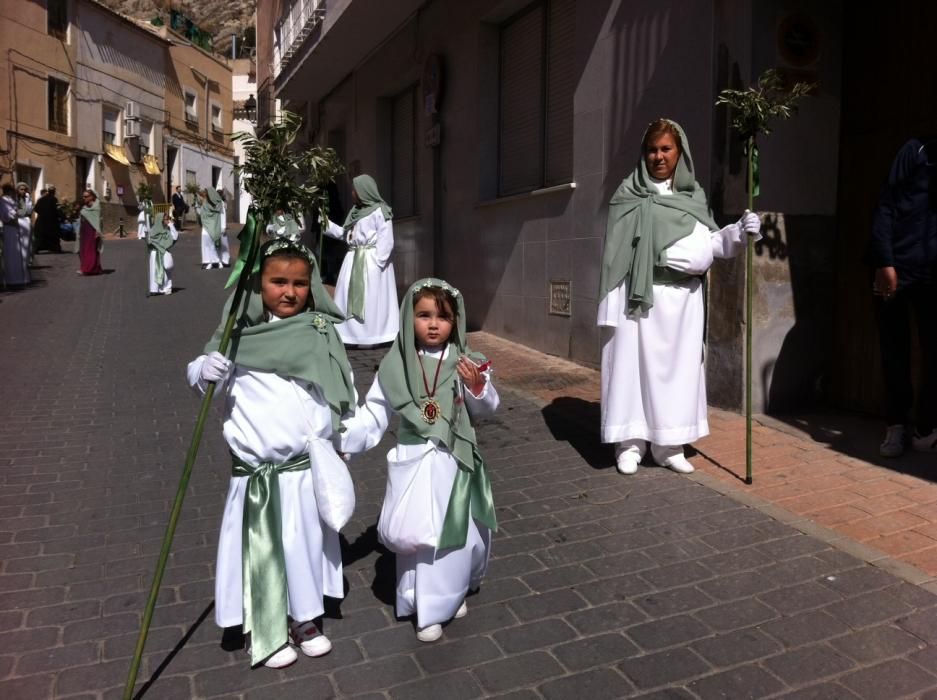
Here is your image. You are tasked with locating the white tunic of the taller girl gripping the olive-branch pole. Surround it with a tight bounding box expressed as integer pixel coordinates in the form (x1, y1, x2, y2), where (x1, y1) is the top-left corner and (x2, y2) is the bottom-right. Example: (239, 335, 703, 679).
(187, 355, 344, 627)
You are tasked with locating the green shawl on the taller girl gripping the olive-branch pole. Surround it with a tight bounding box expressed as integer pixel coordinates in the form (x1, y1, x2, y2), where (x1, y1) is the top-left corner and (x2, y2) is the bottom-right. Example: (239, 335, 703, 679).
(205, 239, 355, 430)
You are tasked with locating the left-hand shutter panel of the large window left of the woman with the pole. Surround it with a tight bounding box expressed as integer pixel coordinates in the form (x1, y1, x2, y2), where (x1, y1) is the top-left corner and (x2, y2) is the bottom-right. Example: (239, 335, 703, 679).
(498, 5, 544, 196)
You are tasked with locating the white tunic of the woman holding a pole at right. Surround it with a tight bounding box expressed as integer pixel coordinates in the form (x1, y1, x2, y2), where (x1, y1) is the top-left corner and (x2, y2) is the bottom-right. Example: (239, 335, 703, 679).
(598, 181, 746, 445)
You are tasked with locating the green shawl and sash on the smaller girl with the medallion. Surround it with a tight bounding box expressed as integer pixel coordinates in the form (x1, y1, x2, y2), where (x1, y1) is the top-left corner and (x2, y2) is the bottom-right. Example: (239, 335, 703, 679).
(377, 278, 498, 549)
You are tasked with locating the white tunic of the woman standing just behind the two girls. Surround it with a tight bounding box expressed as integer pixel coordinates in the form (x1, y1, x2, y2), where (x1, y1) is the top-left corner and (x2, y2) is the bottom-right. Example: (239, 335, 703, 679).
(325, 208, 400, 345)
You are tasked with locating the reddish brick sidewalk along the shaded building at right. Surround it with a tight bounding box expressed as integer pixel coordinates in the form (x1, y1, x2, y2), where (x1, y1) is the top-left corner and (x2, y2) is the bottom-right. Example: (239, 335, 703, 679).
(472, 333, 937, 592)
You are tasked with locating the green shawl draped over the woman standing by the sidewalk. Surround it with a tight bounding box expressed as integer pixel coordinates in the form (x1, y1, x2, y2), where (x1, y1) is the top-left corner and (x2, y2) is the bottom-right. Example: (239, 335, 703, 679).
(599, 121, 719, 315)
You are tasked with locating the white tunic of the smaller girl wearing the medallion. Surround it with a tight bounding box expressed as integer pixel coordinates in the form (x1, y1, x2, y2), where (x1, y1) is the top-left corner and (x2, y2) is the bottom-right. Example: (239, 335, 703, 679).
(341, 348, 499, 627)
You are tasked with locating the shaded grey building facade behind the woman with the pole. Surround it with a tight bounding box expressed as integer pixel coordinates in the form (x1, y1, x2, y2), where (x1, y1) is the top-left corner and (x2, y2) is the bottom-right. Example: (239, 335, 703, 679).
(258, 0, 937, 411)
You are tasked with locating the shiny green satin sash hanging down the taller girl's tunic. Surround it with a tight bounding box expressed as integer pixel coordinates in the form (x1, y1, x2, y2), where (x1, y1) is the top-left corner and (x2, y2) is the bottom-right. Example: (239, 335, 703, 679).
(231, 454, 309, 665)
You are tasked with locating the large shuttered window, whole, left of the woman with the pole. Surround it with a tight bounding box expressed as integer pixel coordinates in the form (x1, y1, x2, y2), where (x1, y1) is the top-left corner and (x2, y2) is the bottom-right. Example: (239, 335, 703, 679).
(498, 0, 575, 196)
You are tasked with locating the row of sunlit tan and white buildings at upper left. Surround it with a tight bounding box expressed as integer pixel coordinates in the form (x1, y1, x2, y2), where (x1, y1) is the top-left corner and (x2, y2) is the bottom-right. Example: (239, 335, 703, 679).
(0, 0, 234, 232)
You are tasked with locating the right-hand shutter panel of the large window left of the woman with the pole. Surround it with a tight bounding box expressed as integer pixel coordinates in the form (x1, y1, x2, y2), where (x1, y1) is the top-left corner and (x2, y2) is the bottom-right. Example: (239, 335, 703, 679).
(544, 0, 576, 185)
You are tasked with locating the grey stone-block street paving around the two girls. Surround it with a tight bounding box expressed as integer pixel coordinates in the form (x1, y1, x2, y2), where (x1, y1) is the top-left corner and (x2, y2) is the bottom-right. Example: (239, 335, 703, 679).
(0, 233, 937, 700)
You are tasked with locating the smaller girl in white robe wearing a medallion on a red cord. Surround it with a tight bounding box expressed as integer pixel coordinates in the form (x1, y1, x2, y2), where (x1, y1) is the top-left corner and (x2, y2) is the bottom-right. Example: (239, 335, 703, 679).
(341, 279, 498, 642)
